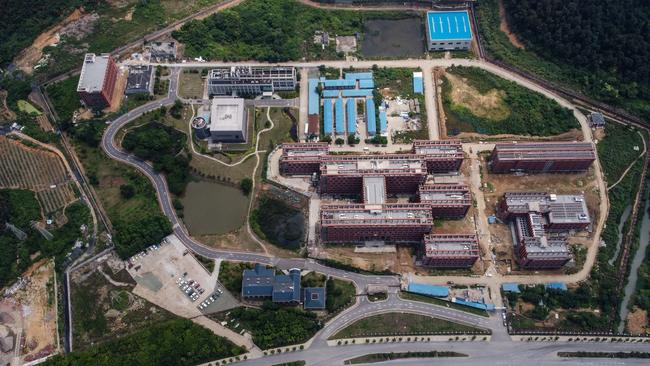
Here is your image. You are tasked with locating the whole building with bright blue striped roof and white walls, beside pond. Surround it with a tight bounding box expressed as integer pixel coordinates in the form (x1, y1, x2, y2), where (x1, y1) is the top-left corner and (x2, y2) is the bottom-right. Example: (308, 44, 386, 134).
(426, 10, 472, 51)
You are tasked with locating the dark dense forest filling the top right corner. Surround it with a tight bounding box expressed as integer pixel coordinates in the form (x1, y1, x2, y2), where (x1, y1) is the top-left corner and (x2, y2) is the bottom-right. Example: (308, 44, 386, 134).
(504, 0, 650, 113)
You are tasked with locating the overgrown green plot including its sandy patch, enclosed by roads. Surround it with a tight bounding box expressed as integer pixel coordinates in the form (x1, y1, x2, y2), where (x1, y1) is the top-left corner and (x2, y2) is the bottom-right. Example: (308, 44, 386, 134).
(439, 66, 580, 139)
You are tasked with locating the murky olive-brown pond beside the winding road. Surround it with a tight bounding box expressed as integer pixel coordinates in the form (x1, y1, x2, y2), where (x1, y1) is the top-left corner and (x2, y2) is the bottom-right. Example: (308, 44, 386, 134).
(181, 180, 248, 235)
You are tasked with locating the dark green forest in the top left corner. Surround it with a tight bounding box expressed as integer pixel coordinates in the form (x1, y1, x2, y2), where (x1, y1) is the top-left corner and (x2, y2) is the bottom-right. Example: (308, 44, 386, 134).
(0, 0, 97, 68)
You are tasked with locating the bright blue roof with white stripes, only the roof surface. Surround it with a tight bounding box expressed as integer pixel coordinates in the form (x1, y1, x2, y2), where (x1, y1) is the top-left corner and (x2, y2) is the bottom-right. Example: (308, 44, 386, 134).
(427, 10, 472, 41)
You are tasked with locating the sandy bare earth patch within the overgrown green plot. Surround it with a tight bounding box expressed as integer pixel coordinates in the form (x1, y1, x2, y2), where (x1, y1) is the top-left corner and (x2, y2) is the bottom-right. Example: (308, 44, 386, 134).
(445, 73, 510, 121)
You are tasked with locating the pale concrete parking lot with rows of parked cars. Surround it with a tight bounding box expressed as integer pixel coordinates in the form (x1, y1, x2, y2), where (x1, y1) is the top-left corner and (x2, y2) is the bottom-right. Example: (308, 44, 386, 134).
(127, 235, 237, 318)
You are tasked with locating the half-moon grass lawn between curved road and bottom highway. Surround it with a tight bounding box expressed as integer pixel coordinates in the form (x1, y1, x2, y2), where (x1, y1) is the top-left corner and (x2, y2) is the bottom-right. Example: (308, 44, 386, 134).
(330, 313, 484, 339)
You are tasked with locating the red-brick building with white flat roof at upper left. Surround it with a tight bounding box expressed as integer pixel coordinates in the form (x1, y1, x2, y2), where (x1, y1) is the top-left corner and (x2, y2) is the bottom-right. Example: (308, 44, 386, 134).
(77, 53, 117, 109)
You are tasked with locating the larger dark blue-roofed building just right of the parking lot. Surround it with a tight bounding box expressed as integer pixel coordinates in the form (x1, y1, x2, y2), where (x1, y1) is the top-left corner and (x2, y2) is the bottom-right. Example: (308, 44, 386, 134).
(241, 263, 301, 304)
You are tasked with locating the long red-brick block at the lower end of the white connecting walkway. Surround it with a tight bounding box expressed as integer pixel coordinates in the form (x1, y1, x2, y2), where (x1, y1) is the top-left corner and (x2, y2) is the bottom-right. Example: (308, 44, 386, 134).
(321, 203, 433, 243)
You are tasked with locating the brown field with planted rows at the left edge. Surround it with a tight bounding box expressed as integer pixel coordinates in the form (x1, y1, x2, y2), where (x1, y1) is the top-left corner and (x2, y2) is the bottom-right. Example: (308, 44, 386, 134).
(0, 136, 76, 214)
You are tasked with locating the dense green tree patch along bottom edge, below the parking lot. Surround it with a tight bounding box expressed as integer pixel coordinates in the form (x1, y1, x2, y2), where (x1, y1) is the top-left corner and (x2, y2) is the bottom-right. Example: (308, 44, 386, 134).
(43, 319, 243, 366)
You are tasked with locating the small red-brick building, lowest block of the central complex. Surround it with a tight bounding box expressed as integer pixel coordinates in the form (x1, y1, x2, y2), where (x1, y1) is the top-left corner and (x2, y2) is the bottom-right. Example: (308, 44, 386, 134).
(422, 234, 480, 268)
